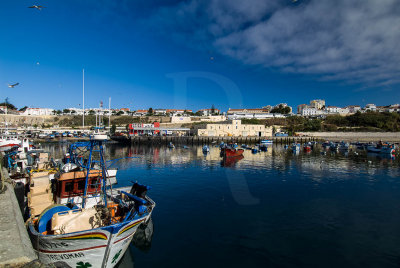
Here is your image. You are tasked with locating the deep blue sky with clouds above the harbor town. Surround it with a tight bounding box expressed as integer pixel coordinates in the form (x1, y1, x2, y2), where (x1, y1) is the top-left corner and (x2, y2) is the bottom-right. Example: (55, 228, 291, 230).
(0, 0, 400, 110)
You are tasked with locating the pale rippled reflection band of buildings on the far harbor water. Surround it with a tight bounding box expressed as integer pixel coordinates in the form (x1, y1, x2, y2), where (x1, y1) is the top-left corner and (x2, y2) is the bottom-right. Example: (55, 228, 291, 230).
(41, 142, 399, 180)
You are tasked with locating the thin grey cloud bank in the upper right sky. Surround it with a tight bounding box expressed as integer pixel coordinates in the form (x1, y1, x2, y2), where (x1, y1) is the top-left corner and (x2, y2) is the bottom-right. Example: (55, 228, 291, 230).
(145, 0, 400, 85)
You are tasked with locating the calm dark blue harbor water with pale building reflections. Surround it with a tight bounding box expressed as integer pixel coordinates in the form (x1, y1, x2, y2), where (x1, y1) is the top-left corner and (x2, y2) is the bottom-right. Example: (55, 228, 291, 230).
(42, 143, 400, 268)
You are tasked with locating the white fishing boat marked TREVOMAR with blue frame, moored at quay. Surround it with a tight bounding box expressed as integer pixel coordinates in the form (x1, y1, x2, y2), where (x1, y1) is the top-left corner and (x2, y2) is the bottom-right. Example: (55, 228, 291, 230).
(27, 136, 155, 268)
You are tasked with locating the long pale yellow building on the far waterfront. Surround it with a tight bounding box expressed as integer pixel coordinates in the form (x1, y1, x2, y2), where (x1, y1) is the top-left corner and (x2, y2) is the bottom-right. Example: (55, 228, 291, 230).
(197, 120, 279, 137)
